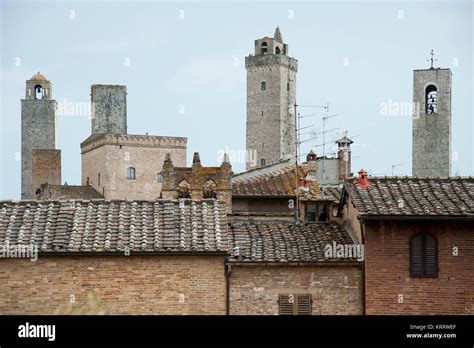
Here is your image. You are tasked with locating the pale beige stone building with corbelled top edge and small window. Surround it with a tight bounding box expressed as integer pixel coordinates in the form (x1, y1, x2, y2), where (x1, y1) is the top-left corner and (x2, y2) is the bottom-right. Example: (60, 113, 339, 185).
(81, 134, 187, 200)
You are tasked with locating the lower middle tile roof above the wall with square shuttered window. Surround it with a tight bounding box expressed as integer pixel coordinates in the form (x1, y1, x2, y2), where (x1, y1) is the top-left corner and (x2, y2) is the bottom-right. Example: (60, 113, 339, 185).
(229, 222, 355, 262)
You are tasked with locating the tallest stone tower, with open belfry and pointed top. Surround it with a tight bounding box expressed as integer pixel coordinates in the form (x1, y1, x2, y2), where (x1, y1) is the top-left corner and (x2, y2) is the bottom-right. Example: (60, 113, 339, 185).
(245, 28, 298, 170)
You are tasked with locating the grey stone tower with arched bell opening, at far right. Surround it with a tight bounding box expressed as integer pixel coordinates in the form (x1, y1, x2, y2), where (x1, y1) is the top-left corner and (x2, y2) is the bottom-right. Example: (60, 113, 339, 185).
(412, 68, 452, 177)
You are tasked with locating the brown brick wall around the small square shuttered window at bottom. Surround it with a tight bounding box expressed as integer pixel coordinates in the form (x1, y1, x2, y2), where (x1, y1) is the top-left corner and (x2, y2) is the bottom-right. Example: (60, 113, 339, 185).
(230, 266, 362, 315)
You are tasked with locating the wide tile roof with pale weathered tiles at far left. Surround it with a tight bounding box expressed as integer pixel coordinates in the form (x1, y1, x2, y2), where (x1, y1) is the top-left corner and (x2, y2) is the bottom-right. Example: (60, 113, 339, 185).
(0, 200, 227, 253)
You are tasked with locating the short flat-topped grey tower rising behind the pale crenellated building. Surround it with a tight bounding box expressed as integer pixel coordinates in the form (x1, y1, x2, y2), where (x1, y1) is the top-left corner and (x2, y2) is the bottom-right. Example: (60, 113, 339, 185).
(91, 85, 127, 134)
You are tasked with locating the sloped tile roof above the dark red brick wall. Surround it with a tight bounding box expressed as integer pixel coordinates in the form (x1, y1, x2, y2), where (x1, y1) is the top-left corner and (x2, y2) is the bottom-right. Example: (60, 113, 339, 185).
(344, 177, 474, 216)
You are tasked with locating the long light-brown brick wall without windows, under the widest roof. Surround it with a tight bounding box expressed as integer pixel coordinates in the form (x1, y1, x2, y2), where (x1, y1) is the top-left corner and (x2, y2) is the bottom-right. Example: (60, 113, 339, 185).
(0, 256, 226, 314)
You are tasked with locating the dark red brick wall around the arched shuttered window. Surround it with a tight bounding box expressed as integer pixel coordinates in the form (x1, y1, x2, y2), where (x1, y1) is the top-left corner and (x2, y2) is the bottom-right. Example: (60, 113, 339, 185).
(365, 222, 474, 314)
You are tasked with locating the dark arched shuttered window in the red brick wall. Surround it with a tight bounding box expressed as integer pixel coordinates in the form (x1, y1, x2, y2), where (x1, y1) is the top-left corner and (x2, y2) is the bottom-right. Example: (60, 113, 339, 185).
(410, 233, 438, 278)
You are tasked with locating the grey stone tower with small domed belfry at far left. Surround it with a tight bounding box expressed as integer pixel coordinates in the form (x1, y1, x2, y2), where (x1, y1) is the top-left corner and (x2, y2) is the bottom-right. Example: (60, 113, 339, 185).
(21, 72, 57, 199)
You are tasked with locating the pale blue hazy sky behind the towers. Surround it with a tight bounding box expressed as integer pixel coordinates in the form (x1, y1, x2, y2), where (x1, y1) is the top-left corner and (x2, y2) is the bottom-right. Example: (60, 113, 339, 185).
(0, 1, 474, 199)
